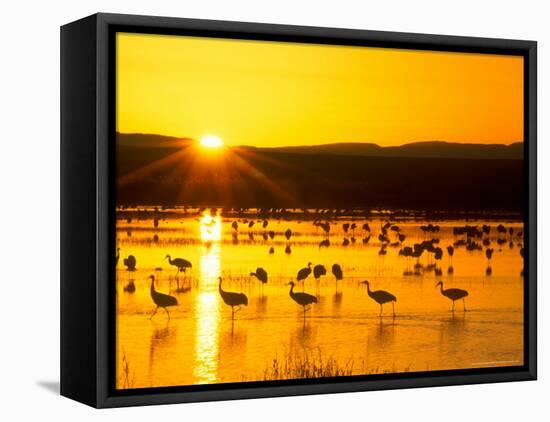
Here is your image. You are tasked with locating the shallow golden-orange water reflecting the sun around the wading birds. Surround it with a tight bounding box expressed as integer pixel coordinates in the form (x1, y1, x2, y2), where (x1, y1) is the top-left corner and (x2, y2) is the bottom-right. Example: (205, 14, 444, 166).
(116, 210, 523, 388)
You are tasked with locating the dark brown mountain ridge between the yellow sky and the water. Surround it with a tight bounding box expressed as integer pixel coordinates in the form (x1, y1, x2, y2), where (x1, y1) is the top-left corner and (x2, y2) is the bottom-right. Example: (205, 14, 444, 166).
(116, 134, 524, 212)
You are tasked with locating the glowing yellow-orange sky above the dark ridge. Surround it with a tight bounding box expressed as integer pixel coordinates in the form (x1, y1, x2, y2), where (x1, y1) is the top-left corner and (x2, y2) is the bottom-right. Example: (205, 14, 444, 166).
(117, 33, 523, 146)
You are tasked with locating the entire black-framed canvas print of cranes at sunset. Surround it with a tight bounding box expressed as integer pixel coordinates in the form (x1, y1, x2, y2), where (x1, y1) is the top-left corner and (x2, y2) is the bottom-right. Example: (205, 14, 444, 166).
(61, 14, 536, 407)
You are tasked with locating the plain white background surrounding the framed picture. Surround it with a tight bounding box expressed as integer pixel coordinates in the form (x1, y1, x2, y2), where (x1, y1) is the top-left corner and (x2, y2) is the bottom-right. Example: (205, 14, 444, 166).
(0, 0, 550, 422)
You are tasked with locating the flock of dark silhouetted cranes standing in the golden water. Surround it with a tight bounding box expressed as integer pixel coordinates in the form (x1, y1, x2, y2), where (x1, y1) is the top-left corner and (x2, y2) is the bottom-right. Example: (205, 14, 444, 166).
(116, 214, 524, 320)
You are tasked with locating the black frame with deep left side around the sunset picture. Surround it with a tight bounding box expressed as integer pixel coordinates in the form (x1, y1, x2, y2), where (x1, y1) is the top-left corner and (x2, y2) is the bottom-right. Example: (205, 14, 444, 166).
(61, 13, 537, 408)
